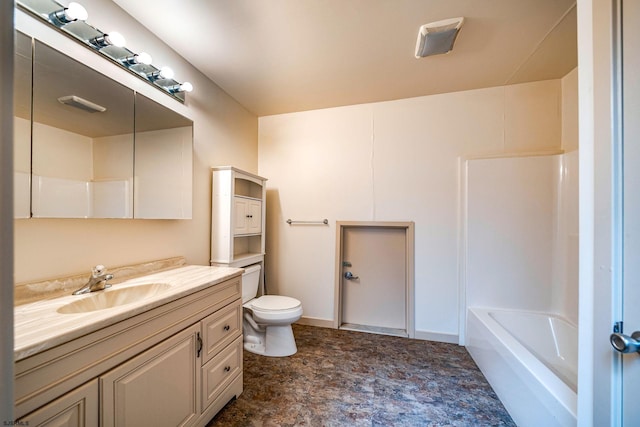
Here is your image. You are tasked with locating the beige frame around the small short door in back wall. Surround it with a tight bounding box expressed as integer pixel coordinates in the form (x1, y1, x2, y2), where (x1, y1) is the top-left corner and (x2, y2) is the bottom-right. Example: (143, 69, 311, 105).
(333, 221, 416, 338)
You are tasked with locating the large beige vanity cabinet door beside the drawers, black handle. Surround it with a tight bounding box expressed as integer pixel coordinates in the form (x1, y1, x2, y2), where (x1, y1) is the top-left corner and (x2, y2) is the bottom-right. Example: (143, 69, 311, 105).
(100, 323, 200, 427)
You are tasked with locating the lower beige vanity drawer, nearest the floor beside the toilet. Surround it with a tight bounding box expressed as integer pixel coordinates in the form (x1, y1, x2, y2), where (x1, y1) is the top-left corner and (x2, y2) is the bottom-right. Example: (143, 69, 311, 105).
(202, 336, 242, 412)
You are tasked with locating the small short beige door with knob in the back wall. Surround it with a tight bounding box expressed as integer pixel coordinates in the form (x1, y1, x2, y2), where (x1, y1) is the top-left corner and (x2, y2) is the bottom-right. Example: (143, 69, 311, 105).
(340, 226, 408, 336)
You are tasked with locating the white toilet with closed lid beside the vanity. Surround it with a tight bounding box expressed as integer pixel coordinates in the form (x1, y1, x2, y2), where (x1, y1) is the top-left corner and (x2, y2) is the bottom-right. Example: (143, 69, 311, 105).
(242, 264, 302, 357)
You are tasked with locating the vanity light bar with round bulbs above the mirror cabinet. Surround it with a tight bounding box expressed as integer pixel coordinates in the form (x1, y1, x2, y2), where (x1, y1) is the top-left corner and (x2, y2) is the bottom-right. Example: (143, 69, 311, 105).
(17, 0, 193, 102)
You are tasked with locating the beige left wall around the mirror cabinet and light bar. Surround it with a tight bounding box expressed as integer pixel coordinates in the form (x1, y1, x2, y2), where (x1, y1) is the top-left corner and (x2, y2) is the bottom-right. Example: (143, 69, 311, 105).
(14, 0, 257, 283)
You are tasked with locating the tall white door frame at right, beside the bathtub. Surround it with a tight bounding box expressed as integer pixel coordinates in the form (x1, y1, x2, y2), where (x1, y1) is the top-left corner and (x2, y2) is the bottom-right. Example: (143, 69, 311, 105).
(577, 0, 618, 426)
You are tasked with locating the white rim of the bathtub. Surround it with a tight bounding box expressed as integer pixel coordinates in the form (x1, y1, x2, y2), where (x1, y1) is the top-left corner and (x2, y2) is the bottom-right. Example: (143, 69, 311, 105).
(465, 307, 578, 419)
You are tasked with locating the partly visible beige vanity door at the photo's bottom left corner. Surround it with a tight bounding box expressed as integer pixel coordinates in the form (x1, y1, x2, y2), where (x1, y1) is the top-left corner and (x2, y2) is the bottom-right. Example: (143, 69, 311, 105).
(16, 380, 98, 427)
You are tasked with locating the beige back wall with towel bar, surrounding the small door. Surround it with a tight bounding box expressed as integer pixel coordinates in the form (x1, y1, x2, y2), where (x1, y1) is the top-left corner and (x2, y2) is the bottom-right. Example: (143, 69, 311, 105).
(259, 80, 562, 338)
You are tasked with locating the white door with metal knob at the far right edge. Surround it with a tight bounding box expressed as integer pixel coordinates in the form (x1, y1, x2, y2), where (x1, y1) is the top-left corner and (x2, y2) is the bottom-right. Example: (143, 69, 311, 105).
(621, 0, 640, 426)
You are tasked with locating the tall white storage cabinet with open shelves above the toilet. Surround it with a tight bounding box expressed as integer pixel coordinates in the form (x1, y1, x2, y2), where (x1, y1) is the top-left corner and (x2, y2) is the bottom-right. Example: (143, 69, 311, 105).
(211, 166, 267, 280)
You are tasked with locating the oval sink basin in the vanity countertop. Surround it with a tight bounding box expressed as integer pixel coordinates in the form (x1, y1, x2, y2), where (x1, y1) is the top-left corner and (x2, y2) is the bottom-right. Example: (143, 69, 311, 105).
(57, 283, 171, 314)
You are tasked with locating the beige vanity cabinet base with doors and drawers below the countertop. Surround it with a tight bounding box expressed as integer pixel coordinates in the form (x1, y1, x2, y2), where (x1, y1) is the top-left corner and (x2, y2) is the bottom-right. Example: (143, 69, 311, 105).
(15, 271, 243, 427)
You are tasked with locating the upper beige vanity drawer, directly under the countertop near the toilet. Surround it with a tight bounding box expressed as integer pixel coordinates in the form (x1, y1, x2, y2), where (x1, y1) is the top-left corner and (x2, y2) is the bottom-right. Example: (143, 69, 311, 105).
(202, 301, 242, 364)
